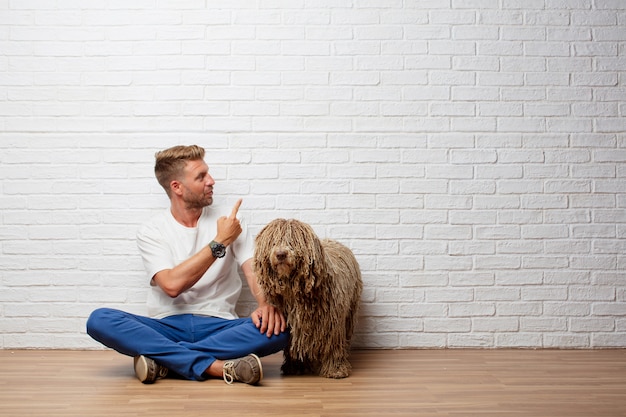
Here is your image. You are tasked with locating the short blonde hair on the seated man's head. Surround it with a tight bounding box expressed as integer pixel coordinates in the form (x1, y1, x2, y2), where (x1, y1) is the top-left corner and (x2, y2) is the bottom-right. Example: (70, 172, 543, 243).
(154, 145, 204, 196)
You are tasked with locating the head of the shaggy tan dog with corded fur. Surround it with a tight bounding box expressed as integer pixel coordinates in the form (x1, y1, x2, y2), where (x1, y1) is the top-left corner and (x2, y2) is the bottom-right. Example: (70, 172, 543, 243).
(254, 219, 325, 298)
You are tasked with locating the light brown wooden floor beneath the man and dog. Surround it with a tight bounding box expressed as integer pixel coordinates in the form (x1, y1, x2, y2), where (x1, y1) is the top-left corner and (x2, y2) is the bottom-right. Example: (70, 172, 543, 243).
(0, 350, 626, 417)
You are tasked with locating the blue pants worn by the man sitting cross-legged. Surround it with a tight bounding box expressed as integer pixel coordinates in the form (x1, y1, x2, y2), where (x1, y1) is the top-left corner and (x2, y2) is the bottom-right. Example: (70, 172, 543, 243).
(87, 308, 289, 381)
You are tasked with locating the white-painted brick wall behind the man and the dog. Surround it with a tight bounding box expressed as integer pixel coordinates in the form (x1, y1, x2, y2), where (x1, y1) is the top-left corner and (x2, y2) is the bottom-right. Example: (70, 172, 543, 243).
(0, 0, 626, 349)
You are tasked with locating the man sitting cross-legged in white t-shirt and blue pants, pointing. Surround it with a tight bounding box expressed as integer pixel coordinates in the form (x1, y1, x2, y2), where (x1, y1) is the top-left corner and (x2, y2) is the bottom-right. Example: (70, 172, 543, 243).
(87, 145, 289, 384)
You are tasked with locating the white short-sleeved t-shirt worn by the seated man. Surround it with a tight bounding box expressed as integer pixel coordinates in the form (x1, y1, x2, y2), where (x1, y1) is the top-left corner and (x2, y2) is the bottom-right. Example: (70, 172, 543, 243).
(137, 206, 254, 319)
